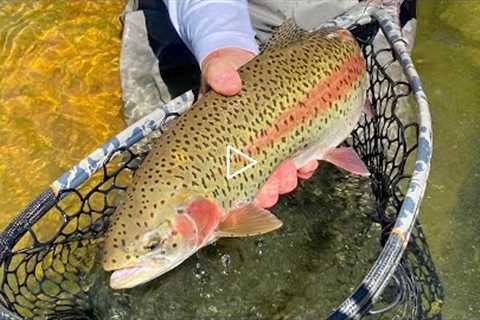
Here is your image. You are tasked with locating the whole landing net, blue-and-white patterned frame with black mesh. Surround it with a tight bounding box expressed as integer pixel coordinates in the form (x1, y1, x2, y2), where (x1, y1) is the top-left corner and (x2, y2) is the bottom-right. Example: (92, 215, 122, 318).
(0, 4, 443, 319)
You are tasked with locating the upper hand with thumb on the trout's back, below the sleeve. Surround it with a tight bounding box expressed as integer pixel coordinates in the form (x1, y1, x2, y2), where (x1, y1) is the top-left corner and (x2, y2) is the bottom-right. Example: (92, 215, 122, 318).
(201, 48, 255, 96)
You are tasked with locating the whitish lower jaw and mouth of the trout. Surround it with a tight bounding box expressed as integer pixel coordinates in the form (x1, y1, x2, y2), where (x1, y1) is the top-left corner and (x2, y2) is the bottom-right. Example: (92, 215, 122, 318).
(110, 254, 191, 290)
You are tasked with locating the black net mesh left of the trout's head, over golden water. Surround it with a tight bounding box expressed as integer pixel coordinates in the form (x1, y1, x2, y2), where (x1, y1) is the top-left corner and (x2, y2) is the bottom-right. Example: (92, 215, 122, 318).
(0, 149, 145, 319)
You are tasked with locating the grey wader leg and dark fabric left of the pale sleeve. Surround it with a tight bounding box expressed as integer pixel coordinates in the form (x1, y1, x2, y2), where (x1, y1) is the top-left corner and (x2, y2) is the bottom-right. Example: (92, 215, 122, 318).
(120, 0, 200, 124)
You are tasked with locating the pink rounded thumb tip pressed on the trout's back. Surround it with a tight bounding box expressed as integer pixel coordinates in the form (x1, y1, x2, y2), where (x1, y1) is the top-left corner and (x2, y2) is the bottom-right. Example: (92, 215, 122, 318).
(204, 58, 242, 96)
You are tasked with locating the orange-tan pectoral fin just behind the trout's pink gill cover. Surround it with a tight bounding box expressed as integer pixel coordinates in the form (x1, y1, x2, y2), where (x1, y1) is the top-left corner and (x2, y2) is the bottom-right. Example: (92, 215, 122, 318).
(215, 204, 282, 238)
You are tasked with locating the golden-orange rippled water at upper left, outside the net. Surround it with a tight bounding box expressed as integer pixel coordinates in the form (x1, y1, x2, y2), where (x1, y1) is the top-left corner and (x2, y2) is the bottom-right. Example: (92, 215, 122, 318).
(0, 0, 124, 227)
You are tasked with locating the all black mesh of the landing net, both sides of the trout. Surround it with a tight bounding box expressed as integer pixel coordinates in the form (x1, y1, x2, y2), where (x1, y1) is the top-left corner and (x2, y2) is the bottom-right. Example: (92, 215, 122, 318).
(0, 25, 443, 319)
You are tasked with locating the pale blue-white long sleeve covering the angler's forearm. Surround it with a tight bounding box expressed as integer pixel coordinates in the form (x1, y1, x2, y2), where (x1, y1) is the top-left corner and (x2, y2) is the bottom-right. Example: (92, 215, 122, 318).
(164, 0, 258, 64)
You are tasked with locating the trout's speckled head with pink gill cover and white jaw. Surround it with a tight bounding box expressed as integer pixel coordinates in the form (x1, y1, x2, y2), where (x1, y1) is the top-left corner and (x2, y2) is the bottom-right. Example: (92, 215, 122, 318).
(103, 192, 222, 289)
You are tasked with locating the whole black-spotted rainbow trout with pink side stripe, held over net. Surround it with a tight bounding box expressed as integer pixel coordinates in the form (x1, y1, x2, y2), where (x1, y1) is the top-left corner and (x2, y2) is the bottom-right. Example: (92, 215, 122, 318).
(103, 21, 368, 289)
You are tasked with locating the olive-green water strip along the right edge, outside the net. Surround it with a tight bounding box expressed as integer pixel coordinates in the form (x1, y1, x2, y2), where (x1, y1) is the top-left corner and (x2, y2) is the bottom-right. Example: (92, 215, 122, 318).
(414, 0, 480, 319)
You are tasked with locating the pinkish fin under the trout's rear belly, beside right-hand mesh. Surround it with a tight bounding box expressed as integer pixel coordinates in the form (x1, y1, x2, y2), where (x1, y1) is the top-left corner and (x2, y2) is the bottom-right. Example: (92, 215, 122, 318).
(323, 147, 370, 176)
